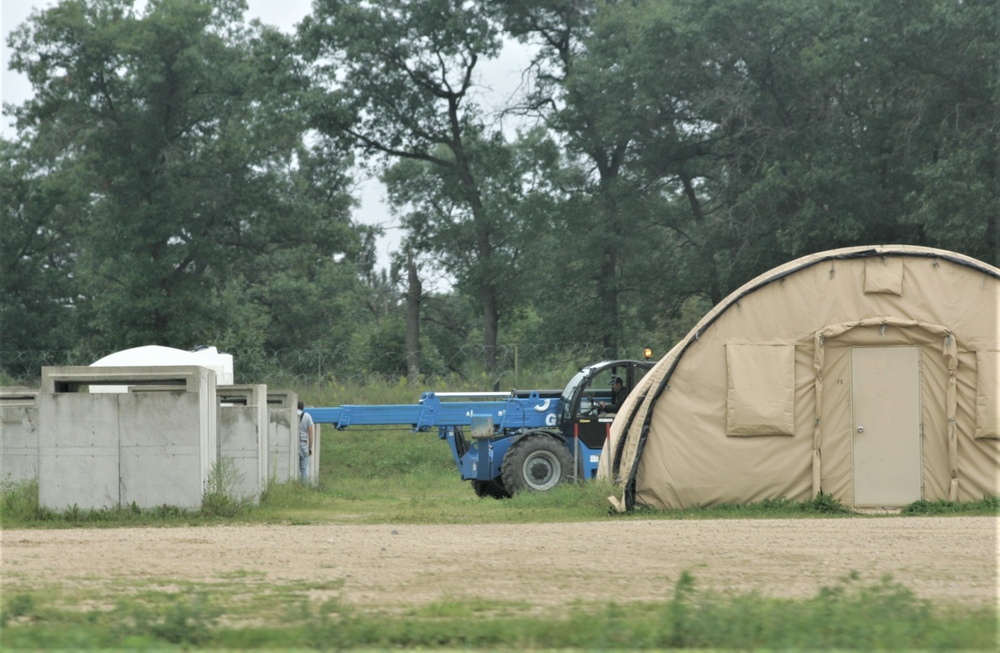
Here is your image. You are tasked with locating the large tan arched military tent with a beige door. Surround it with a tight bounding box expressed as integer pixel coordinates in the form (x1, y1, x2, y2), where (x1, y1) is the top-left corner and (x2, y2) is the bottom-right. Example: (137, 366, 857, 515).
(599, 246, 1000, 510)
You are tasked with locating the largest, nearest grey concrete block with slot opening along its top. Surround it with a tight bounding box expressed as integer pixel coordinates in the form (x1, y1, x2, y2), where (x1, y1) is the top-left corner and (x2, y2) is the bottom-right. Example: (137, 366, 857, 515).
(37, 366, 218, 510)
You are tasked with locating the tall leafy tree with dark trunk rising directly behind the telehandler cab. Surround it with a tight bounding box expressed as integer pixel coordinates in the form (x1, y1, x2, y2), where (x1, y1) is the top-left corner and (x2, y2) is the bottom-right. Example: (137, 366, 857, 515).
(498, 0, 696, 356)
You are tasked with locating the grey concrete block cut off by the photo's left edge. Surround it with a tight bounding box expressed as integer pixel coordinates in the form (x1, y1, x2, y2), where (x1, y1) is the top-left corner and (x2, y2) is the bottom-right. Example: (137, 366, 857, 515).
(0, 387, 39, 483)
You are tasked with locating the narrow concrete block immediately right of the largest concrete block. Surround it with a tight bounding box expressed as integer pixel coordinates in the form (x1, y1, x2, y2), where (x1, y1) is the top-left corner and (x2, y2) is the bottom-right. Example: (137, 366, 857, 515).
(216, 385, 270, 503)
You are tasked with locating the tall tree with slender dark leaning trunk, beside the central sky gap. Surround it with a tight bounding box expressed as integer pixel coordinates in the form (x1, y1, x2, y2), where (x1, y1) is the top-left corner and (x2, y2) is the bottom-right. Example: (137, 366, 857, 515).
(299, 0, 520, 369)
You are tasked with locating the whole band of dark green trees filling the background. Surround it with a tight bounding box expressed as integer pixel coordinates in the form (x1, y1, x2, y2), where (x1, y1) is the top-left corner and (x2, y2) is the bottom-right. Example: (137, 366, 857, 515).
(0, 0, 1000, 383)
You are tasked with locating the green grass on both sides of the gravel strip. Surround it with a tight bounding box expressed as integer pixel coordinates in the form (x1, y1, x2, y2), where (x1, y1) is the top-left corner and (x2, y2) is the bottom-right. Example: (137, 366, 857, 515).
(0, 388, 998, 651)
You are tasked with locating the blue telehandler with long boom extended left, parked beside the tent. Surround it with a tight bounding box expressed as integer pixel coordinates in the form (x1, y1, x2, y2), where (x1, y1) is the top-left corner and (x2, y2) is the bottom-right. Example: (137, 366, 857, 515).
(305, 349, 653, 499)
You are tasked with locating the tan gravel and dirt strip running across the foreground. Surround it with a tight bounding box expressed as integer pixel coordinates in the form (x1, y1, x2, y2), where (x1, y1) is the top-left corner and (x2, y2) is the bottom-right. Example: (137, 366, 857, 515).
(0, 517, 1000, 610)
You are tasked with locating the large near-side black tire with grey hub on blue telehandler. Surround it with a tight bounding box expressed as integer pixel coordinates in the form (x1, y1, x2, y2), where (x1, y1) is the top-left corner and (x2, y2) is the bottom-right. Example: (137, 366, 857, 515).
(500, 434, 573, 496)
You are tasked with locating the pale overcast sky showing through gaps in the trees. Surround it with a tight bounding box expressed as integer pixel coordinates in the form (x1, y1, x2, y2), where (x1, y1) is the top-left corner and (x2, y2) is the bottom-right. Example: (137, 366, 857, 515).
(0, 0, 528, 278)
